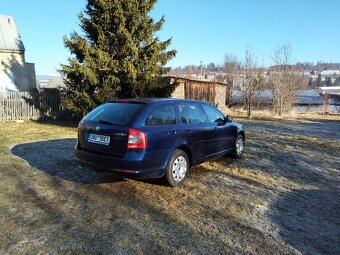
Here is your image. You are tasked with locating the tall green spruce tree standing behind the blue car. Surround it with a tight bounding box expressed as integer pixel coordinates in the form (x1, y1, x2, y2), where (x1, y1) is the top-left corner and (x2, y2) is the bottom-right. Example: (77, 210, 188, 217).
(60, 0, 176, 116)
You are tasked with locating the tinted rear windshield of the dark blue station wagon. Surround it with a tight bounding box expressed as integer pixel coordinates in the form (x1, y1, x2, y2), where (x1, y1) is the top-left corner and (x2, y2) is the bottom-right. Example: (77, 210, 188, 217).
(85, 102, 145, 126)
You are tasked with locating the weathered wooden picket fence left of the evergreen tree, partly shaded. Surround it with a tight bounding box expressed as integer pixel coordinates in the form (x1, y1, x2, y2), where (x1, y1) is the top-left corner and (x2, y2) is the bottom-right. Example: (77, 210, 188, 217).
(0, 90, 67, 122)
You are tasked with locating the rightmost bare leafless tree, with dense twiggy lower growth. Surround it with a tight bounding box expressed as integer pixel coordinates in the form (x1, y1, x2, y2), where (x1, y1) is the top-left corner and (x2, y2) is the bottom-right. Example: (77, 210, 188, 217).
(271, 44, 300, 116)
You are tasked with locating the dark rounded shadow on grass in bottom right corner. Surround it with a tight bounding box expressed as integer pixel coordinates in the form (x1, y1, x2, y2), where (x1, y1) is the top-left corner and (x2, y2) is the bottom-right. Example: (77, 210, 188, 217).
(269, 189, 340, 254)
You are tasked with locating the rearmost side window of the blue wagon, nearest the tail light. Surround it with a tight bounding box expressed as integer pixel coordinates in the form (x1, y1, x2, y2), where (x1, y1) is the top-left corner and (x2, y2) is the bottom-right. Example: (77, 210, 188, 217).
(146, 105, 176, 125)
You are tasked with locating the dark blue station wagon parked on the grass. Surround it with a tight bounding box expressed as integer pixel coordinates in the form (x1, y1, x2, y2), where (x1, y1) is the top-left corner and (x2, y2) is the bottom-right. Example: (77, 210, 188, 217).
(75, 98, 245, 186)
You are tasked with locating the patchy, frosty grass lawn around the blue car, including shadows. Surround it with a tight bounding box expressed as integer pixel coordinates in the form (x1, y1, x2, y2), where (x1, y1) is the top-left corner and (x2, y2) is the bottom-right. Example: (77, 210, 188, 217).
(0, 119, 340, 254)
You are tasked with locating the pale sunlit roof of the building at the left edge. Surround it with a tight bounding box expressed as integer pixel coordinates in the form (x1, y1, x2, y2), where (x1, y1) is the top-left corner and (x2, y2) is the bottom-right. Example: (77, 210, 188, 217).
(0, 15, 25, 51)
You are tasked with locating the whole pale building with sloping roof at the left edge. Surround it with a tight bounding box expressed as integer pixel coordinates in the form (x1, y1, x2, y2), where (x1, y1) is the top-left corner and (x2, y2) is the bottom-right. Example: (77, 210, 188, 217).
(0, 15, 36, 92)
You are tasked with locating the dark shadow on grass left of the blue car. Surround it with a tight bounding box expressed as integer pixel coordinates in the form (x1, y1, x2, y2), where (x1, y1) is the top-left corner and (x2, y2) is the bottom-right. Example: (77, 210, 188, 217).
(11, 139, 124, 184)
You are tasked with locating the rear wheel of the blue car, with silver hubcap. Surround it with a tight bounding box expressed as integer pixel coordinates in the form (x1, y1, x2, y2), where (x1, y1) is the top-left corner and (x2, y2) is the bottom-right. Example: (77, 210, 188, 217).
(164, 150, 190, 187)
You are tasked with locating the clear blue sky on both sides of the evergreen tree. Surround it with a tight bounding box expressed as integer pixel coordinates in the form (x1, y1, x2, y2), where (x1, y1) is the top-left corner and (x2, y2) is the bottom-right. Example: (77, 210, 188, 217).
(0, 0, 340, 75)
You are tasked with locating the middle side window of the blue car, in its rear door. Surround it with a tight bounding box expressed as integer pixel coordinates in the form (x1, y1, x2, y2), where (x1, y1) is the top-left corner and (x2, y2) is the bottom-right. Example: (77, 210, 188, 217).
(179, 104, 206, 124)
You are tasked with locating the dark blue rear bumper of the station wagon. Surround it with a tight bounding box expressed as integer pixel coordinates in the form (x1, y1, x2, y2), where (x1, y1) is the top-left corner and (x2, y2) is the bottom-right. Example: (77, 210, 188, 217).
(75, 146, 171, 179)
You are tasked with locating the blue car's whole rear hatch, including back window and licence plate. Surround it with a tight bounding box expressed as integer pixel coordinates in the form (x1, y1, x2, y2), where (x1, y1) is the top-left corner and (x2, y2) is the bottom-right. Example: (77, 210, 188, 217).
(78, 101, 145, 157)
